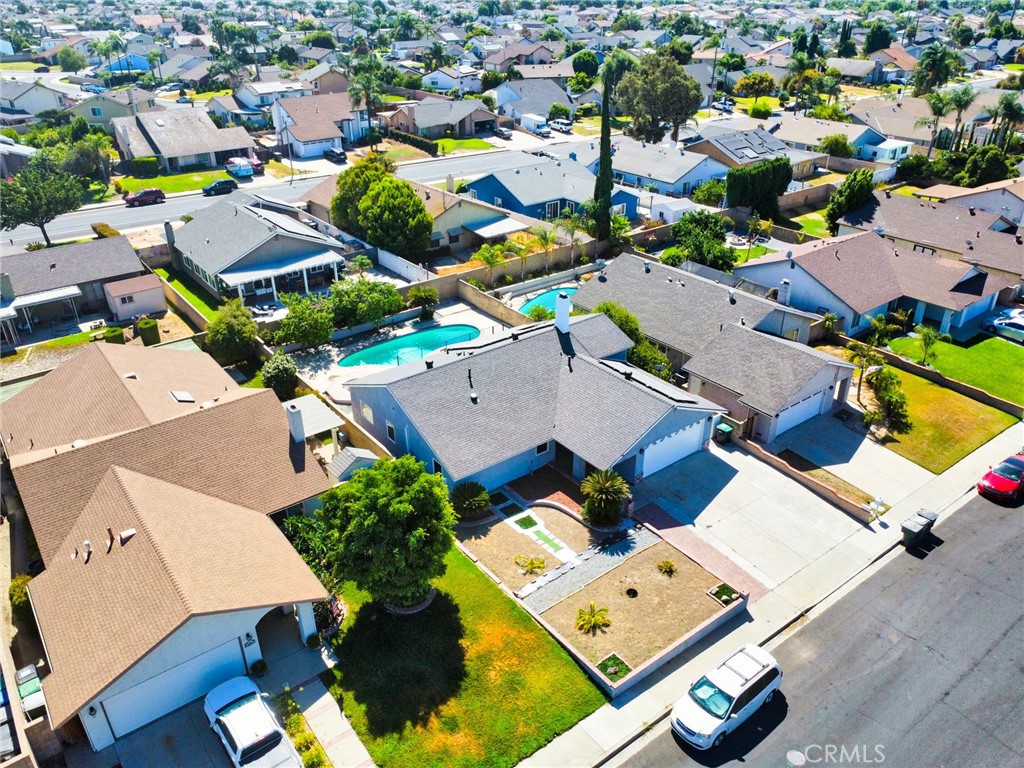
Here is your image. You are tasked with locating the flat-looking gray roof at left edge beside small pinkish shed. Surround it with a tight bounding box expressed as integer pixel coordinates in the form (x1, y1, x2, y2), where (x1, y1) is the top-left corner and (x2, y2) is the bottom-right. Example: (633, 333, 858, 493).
(0, 236, 142, 298)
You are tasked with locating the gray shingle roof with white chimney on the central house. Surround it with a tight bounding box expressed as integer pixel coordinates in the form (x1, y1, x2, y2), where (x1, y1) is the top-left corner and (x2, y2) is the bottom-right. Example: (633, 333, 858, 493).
(350, 314, 718, 480)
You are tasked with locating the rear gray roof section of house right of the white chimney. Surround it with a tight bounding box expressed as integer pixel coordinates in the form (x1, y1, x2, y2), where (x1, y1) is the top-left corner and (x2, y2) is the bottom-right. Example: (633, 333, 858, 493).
(572, 254, 786, 354)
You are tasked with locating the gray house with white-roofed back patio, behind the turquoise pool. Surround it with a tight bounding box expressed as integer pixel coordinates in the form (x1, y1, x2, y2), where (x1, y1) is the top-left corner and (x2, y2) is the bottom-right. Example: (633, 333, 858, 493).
(165, 191, 364, 303)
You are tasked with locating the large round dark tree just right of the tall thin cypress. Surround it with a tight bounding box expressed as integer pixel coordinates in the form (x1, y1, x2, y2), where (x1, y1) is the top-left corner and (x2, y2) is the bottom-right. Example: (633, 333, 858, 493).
(614, 55, 700, 142)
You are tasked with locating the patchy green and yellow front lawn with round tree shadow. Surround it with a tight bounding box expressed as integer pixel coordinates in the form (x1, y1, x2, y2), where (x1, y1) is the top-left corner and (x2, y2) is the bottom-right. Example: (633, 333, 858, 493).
(323, 548, 604, 768)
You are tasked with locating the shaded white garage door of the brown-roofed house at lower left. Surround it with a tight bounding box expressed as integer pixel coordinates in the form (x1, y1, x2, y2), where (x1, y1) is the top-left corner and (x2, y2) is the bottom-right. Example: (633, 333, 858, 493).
(103, 638, 246, 738)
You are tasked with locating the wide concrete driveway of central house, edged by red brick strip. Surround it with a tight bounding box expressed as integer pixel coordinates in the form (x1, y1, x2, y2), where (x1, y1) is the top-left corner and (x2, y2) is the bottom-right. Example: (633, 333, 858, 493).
(634, 443, 863, 589)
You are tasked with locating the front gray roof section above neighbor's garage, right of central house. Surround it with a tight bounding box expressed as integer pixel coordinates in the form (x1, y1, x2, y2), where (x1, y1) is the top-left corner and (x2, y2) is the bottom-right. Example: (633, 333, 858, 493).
(683, 326, 854, 416)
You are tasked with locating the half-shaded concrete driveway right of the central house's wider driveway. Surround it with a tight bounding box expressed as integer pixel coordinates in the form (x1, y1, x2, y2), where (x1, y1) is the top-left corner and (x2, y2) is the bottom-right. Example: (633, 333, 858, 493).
(768, 415, 935, 506)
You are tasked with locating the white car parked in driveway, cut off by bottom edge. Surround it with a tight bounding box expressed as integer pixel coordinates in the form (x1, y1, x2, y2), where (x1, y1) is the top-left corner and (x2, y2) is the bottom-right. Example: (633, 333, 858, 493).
(203, 677, 302, 768)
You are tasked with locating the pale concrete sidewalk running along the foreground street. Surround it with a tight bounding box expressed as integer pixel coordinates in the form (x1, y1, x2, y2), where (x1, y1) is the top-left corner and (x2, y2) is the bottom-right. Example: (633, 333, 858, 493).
(519, 424, 1024, 768)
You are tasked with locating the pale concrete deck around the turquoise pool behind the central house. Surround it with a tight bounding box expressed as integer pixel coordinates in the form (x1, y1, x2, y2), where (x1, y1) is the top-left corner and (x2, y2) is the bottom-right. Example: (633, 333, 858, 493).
(295, 302, 507, 401)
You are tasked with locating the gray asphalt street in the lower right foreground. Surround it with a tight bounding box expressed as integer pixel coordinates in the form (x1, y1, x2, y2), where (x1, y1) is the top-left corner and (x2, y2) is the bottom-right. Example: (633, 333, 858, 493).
(609, 498, 1024, 768)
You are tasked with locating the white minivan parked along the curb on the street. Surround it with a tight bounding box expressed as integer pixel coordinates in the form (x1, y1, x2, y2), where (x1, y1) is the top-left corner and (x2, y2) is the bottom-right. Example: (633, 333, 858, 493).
(672, 644, 782, 750)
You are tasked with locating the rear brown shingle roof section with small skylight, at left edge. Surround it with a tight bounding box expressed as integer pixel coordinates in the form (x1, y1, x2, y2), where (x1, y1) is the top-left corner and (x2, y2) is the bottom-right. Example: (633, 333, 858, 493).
(0, 344, 237, 464)
